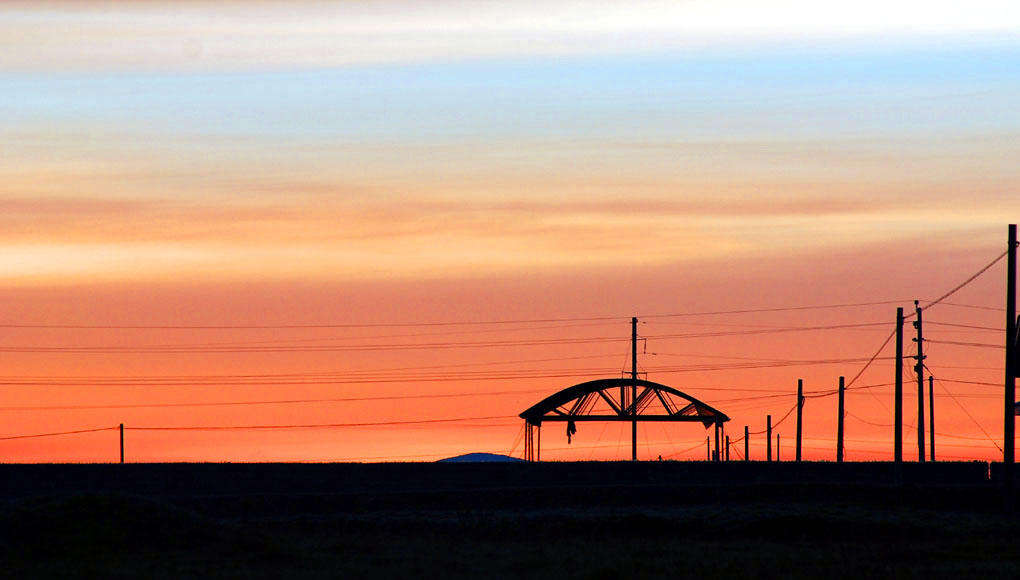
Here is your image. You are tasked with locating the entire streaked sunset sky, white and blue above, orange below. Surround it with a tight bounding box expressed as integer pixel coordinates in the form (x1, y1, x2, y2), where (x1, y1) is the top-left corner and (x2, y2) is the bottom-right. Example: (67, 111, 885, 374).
(0, 0, 1020, 462)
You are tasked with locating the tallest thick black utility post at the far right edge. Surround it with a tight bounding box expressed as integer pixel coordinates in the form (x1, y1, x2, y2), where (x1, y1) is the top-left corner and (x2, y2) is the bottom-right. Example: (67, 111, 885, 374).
(1003, 223, 1020, 505)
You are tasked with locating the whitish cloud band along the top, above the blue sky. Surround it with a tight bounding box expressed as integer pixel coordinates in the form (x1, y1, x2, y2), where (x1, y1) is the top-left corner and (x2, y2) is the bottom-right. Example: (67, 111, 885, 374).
(0, 0, 1020, 71)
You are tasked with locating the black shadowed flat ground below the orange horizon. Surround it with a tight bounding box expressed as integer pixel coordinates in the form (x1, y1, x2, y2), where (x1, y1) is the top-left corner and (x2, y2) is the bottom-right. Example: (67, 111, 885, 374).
(0, 463, 1020, 580)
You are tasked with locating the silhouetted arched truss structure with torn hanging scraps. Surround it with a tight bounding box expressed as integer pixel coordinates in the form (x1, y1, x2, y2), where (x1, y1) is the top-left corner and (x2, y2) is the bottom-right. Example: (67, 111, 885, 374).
(520, 378, 729, 461)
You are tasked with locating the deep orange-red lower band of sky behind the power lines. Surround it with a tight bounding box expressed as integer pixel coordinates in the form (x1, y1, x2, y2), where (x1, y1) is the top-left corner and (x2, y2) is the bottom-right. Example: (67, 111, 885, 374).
(0, 235, 1004, 461)
